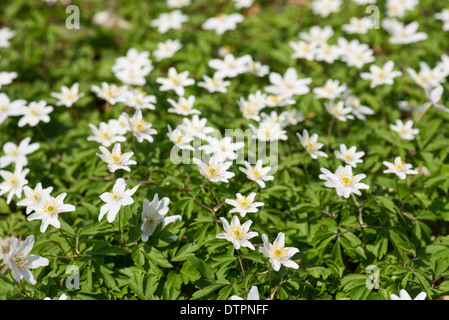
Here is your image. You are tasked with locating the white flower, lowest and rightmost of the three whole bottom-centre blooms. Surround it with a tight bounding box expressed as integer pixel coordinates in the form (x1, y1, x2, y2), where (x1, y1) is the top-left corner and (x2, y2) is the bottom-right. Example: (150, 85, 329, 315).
(259, 232, 299, 271)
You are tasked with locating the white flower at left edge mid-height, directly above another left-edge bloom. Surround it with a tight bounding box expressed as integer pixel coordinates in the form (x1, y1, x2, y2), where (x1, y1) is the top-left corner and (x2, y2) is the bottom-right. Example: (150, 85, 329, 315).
(0, 137, 40, 168)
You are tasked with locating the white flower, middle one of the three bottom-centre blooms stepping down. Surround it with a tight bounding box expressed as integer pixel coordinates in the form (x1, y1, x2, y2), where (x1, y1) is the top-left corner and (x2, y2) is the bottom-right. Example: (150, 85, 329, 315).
(216, 216, 258, 250)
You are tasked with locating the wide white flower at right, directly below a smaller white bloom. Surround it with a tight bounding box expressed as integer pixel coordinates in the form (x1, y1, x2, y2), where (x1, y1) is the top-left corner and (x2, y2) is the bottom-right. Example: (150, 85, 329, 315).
(319, 165, 369, 198)
